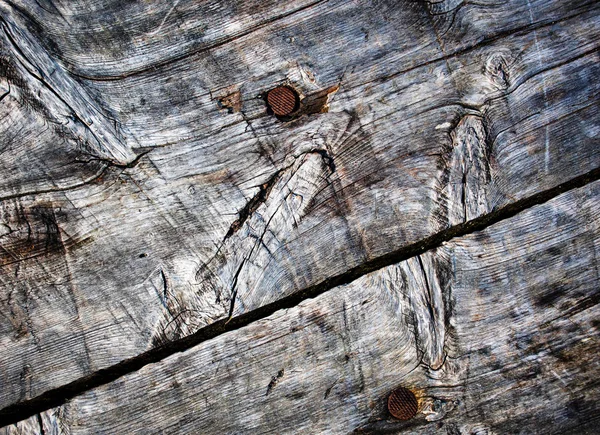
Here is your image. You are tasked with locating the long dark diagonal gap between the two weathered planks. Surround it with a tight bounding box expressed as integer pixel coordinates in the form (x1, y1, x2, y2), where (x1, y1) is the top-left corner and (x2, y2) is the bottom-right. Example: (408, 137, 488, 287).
(0, 168, 600, 427)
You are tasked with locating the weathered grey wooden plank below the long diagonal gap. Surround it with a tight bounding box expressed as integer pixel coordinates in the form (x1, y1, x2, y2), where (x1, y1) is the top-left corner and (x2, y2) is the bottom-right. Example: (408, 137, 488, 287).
(4, 182, 600, 435)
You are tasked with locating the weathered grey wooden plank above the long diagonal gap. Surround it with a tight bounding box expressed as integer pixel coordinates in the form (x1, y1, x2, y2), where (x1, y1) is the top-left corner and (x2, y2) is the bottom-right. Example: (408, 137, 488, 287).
(0, 0, 600, 418)
